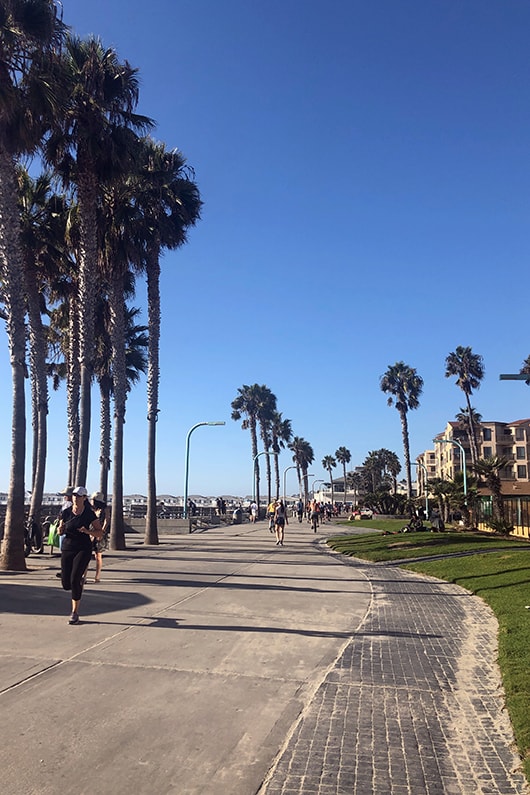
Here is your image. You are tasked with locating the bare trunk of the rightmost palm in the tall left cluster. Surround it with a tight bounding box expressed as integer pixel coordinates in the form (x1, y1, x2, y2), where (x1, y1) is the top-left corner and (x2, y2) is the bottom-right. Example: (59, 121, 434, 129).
(144, 245, 160, 544)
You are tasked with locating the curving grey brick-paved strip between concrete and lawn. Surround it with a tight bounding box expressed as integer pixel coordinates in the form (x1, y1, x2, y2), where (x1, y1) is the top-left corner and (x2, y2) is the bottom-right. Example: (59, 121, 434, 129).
(260, 561, 530, 795)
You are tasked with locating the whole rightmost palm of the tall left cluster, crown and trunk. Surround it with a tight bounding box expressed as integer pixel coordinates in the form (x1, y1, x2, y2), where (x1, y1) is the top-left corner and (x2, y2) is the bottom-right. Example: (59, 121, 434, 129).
(133, 138, 202, 544)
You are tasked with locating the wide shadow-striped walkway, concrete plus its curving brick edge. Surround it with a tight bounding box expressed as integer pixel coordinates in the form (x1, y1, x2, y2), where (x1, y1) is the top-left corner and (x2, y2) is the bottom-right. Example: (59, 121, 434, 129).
(0, 522, 530, 795)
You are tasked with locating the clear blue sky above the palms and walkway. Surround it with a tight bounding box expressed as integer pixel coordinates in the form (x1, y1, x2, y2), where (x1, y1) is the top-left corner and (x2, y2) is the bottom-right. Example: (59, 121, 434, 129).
(0, 0, 530, 495)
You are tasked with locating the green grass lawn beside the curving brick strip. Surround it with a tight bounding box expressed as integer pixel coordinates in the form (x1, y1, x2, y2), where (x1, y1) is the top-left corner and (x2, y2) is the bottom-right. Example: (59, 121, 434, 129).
(328, 519, 530, 782)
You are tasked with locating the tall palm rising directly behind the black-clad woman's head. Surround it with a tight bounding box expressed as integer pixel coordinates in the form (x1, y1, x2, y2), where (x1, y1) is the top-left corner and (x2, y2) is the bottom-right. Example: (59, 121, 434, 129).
(45, 36, 152, 485)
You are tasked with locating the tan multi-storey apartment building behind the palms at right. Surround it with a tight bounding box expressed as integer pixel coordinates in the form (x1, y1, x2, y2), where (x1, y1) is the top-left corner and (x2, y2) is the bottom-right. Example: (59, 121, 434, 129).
(416, 419, 530, 495)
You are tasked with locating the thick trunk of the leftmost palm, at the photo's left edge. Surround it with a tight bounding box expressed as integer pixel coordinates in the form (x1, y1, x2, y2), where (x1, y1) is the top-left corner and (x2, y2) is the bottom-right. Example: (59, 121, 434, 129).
(0, 148, 26, 571)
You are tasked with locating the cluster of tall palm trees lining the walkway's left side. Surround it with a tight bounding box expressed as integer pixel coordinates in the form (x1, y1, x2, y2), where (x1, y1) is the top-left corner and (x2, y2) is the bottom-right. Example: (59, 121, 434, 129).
(0, 0, 201, 570)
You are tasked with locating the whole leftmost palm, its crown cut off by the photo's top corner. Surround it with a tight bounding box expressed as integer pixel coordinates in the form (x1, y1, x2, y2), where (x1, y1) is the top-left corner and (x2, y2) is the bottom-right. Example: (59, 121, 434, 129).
(0, 0, 64, 571)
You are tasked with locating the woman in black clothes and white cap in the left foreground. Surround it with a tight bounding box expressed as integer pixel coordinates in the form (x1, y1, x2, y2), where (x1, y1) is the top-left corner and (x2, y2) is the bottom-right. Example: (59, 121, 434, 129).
(59, 486, 103, 624)
